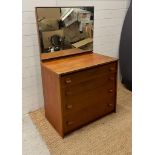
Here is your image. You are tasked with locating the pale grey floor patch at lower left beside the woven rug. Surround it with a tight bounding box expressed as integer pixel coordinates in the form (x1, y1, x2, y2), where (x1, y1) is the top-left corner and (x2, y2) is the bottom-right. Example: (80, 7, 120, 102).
(22, 114, 50, 155)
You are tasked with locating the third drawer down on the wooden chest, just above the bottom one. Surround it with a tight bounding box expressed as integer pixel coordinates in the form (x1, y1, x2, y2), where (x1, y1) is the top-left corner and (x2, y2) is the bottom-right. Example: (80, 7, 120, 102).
(63, 79, 116, 115)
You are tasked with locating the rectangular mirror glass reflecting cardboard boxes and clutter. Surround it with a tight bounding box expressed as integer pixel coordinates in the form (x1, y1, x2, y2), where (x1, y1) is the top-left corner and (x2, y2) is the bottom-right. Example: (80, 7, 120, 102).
(36, 7, 94, 57)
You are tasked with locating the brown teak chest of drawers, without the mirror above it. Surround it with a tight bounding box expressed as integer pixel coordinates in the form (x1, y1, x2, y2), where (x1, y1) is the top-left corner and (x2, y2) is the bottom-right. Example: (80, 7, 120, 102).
(41, 49, 117, 137)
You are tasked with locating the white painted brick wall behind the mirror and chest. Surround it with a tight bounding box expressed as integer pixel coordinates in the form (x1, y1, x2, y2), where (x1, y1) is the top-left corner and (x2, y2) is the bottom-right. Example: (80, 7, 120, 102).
(22, 0, 130, 114)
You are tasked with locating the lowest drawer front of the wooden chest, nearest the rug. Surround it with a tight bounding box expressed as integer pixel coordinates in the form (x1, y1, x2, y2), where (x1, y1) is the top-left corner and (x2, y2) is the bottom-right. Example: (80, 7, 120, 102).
(64, 99, 115, 133)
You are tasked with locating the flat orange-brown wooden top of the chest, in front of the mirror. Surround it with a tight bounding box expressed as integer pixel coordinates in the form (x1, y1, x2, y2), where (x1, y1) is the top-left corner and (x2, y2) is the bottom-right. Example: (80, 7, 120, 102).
(42, 53, 117, 75)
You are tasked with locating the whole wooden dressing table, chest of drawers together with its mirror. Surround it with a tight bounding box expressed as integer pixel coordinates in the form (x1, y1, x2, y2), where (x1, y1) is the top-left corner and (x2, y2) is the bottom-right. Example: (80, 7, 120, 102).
(36, 6, 118, 137)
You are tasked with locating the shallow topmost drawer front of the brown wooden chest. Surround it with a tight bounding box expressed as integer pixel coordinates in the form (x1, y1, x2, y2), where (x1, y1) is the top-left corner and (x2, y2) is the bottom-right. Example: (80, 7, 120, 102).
(61, 61, 117, 87)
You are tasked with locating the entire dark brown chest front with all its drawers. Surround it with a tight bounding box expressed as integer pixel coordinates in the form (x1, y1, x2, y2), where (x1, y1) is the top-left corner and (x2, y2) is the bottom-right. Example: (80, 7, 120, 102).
(61, 62, 117, 134)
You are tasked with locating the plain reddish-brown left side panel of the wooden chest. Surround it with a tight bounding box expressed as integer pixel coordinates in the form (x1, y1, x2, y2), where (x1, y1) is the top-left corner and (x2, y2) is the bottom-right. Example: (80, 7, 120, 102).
(41, 66, 63, 136)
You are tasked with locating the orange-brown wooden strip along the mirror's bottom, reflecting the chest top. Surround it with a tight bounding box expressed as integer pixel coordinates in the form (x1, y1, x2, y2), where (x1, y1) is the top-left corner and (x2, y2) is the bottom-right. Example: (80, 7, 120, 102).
(40, 48, 90, 60)
